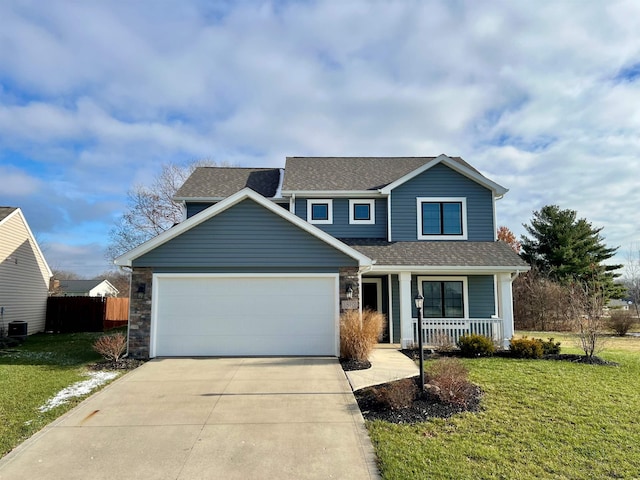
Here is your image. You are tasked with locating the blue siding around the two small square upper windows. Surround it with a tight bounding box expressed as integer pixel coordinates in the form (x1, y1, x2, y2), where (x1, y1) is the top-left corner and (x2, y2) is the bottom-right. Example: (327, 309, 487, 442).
(296, 198, 387, 238)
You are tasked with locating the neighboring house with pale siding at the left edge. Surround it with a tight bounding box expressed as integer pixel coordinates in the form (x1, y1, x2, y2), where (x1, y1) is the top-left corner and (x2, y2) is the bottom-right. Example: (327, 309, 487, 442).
(0, 207, 51, 334)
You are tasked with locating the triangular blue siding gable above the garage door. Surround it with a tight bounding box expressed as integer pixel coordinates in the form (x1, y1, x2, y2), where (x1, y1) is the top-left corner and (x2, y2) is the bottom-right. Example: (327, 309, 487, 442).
(133, 200, 357, 271)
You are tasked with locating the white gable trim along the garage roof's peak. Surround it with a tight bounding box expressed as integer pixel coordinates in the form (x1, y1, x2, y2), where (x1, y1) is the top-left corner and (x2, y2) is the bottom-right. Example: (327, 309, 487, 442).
(113, 188, 373, 267)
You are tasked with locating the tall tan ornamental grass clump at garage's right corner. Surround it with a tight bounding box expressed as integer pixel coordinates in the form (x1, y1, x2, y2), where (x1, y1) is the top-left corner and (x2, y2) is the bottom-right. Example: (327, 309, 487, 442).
(340, 309, 384, 362)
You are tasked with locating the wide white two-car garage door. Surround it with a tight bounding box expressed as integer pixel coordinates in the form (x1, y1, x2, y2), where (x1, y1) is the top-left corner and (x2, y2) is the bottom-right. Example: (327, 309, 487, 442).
(151, 274, 338, 356)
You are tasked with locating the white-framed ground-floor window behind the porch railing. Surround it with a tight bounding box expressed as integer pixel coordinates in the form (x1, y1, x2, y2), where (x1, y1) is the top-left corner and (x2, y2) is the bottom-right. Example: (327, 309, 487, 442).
(419, 277, 468, 318)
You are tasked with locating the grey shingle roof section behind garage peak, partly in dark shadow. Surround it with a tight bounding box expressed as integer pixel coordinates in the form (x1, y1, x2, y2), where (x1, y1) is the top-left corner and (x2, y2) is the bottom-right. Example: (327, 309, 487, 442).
(174, 167, 280, 199)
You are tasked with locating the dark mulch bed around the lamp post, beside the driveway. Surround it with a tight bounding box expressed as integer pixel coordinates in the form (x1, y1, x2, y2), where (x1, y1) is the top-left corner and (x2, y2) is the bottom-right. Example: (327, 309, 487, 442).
(354, 377, 482, 423)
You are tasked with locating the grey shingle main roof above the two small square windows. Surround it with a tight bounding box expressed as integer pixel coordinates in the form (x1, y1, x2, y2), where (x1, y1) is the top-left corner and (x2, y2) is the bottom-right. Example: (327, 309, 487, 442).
(282, 157, 479, 191)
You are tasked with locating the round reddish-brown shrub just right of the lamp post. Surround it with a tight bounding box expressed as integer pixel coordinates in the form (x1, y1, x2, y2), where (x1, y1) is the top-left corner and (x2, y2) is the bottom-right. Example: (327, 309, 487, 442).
(425, 357, 476, 405)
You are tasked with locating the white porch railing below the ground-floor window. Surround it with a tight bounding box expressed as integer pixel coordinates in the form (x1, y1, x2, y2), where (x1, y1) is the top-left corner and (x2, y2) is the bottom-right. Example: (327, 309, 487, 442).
(413, 318, 503, 346)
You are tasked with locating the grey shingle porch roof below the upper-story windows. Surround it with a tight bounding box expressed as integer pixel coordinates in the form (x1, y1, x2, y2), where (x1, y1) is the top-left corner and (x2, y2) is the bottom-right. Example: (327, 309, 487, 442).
(340, 238, 528, 268)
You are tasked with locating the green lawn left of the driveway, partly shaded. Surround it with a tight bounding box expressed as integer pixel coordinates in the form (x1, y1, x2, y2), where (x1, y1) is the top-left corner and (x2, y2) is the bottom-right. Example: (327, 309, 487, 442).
(0, 333, 122, 456)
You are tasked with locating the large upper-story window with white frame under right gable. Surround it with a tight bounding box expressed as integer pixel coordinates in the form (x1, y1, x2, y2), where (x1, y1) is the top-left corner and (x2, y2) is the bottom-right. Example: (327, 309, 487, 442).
(417, 197, 467, 240)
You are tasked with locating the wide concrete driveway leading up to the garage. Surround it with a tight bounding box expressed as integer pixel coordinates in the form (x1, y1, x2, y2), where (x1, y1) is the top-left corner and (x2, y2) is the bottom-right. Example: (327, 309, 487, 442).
(0, 358, 378, 480)
